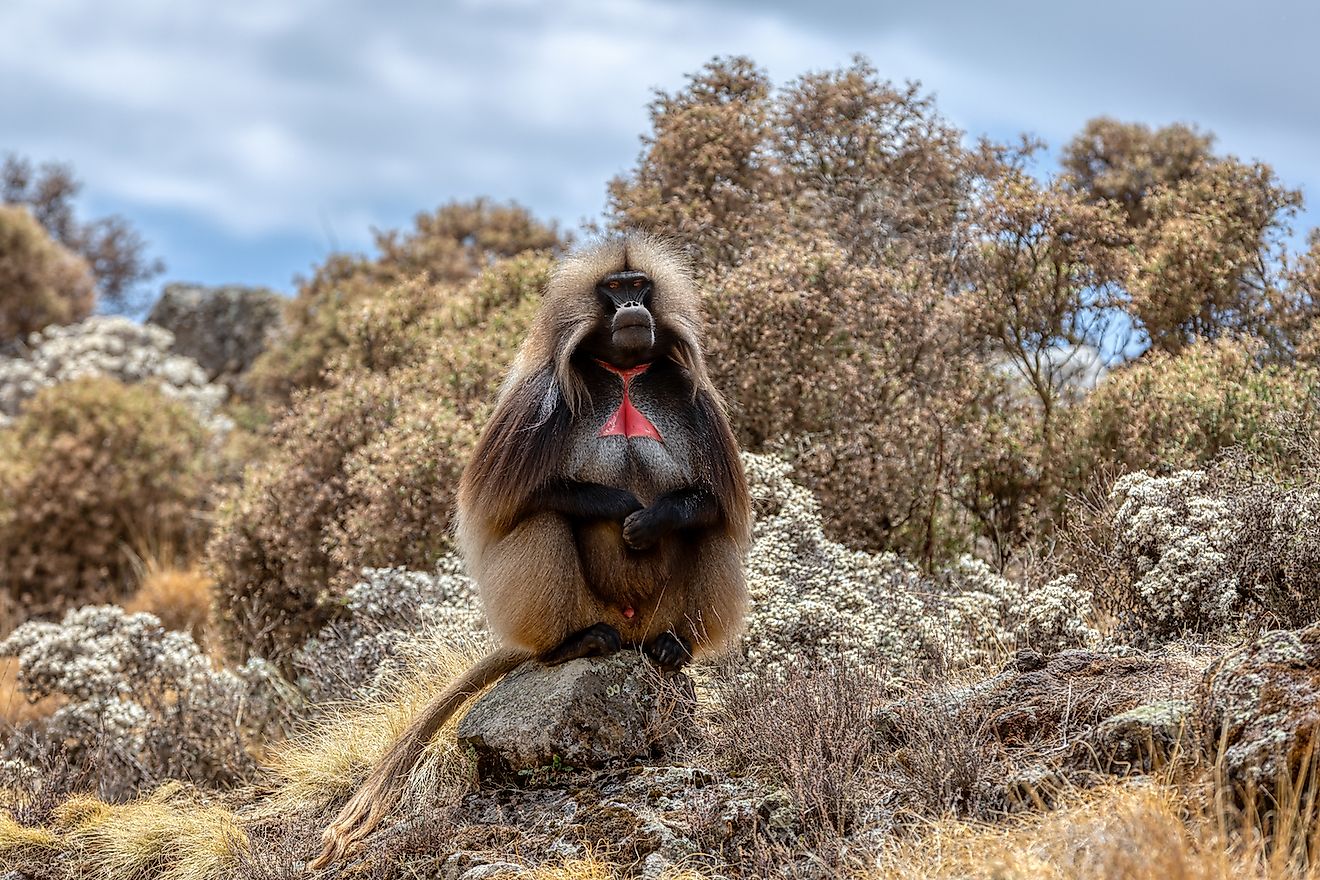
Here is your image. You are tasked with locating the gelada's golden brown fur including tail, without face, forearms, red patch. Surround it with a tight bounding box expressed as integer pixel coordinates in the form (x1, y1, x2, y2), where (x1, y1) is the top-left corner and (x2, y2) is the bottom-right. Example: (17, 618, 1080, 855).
(312, 234, 751, 868)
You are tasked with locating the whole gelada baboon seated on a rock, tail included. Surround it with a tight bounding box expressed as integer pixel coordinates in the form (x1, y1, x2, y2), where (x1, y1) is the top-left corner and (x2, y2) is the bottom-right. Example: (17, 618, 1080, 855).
(312, 234, 750, 868)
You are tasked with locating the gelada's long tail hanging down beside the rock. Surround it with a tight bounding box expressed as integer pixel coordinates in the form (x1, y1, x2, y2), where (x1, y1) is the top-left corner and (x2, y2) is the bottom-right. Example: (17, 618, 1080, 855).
(308, 648, 535, 871)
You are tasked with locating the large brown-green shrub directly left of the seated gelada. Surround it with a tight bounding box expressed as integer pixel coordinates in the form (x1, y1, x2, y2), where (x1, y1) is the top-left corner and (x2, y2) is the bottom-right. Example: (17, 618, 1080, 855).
(209, 255, 550, 664)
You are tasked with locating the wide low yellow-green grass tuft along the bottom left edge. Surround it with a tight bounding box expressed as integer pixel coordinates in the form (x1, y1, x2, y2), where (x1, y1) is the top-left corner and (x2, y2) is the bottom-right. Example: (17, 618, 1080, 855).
(55, 785, 248, 880)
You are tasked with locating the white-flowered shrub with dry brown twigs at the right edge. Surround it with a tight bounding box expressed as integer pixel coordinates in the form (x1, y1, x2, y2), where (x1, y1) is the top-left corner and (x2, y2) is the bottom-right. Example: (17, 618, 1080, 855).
(1068, 440, 1320, 640)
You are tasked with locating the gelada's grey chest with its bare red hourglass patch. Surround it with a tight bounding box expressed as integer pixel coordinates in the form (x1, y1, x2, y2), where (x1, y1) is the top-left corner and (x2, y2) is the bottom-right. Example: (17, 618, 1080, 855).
(568, 371, 694, 503)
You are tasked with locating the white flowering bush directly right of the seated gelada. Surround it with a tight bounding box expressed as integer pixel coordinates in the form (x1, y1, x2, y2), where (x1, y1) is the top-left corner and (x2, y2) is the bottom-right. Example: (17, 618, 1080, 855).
(743, 454, 1098, 676)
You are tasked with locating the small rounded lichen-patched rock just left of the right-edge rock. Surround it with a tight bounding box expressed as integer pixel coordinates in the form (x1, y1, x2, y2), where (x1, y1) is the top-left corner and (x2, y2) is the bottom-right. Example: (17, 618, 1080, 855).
(1073, 699, 1192, 776)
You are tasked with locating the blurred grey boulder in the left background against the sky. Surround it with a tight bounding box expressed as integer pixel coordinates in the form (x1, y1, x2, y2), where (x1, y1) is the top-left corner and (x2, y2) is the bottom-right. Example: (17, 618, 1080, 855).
(147, 284, 285, 381)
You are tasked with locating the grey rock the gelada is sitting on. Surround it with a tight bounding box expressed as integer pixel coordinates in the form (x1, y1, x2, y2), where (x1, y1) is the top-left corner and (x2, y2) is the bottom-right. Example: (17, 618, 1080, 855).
(458, 650, 692, 780)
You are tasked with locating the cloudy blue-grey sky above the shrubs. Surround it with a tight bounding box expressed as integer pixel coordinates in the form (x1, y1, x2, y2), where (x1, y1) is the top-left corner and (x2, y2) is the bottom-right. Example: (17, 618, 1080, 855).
(0, 0, 1320, 298)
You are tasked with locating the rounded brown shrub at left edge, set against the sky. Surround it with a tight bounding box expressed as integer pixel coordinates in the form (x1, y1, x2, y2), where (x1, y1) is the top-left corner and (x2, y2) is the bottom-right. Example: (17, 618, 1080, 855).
(0, 204, 96, 346)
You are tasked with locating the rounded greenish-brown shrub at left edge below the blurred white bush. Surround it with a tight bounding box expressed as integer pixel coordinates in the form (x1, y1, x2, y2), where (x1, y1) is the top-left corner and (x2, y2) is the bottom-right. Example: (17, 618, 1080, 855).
(0, 377, 209, 610)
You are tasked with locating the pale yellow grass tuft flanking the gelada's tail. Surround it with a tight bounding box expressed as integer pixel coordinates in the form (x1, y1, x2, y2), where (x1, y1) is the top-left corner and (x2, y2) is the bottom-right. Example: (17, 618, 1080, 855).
(261, 641, 488, 814)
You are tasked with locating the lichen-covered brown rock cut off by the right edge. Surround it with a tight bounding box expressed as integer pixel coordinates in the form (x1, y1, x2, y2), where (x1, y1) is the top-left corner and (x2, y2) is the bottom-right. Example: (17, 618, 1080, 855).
(1196, 623, 1320, 789)
